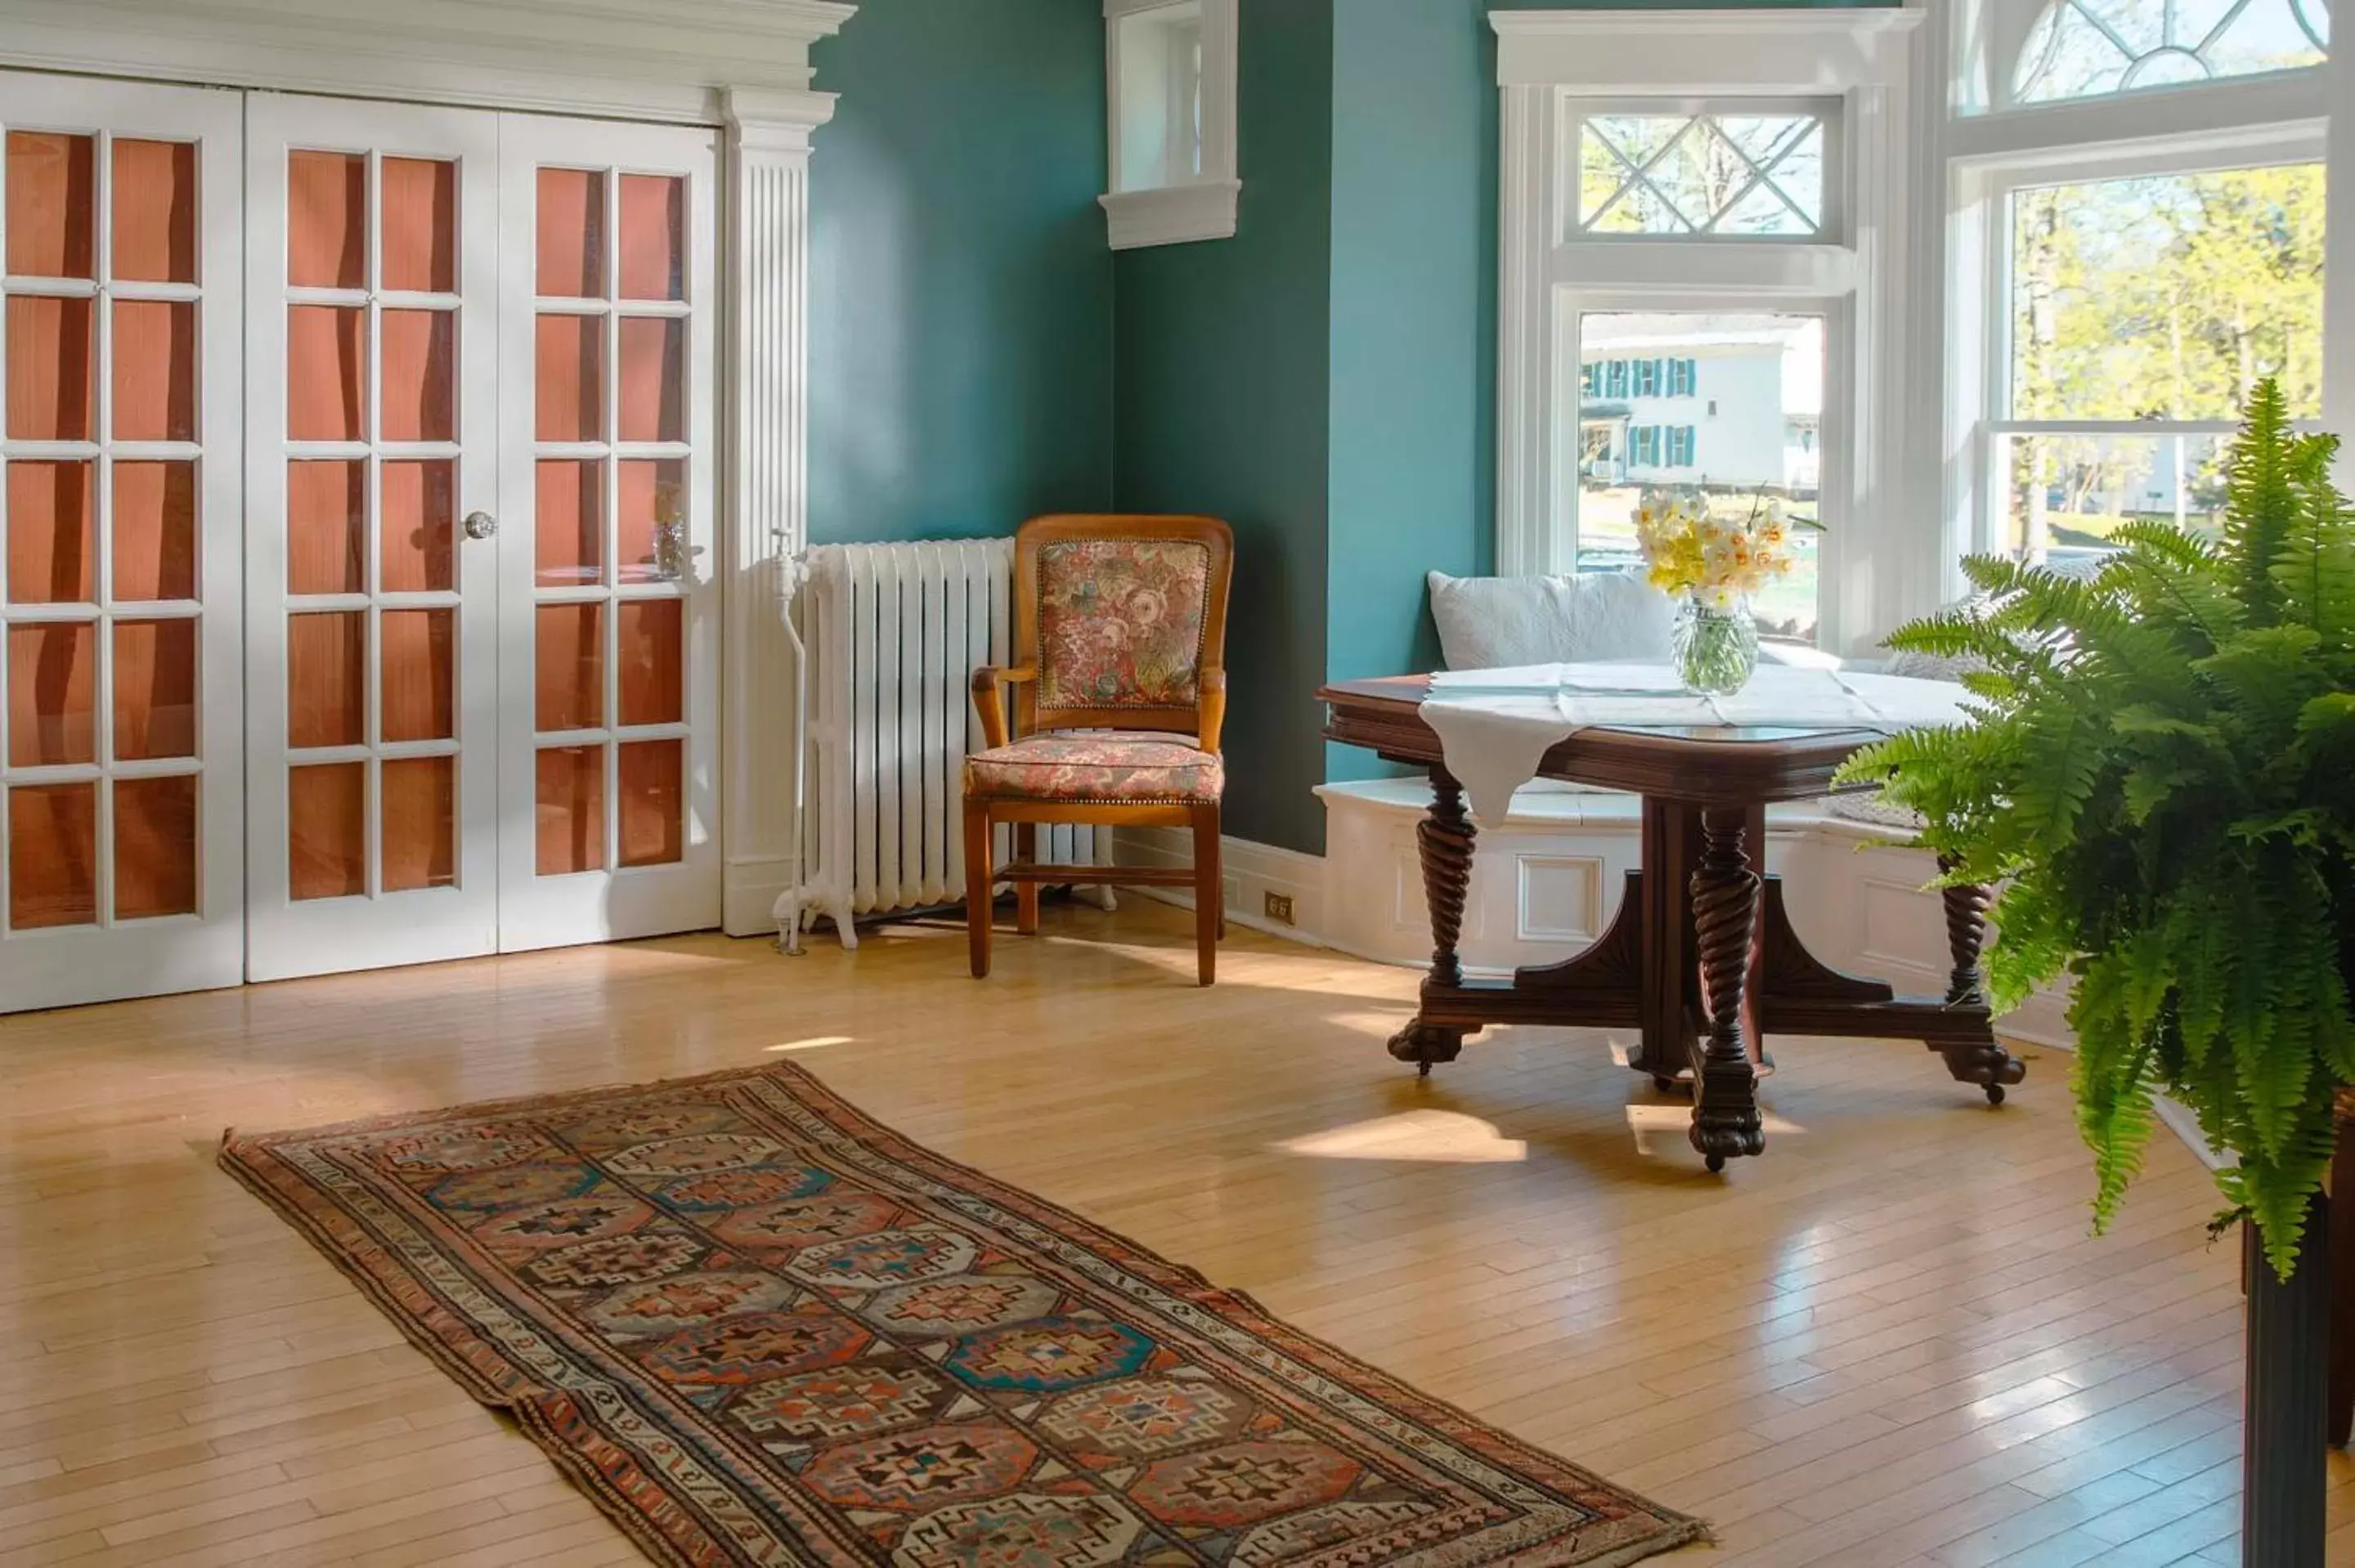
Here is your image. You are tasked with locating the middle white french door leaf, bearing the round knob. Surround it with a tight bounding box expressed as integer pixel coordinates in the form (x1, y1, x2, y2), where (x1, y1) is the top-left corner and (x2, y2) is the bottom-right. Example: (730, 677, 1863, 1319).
(247, 96, 500, 977)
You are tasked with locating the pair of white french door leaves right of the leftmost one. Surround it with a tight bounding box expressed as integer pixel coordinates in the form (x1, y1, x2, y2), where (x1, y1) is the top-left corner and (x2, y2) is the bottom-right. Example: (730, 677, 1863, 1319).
(245, 94, 718, 979)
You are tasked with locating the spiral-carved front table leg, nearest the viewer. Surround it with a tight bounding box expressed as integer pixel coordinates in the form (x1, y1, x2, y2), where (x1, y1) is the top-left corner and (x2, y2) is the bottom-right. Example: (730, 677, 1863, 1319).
(1691, 808, 1766, 1170)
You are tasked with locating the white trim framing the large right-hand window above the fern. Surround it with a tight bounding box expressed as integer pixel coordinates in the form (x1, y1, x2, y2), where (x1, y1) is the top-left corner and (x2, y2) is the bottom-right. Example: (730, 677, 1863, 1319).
(1913, 0, 2355, 595)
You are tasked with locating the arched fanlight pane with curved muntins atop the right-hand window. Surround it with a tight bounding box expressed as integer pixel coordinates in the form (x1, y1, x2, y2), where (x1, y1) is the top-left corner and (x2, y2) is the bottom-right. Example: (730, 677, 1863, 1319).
(2012, 0, 2329, 104)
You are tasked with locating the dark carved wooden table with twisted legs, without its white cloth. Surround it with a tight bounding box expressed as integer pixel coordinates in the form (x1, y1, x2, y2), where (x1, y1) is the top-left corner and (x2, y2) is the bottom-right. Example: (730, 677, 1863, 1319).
(1317, 676, 2028, 1170)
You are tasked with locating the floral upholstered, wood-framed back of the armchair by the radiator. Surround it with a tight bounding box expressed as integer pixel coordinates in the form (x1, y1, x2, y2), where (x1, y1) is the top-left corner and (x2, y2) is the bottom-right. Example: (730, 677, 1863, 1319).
(1015, 516, 1234, 735)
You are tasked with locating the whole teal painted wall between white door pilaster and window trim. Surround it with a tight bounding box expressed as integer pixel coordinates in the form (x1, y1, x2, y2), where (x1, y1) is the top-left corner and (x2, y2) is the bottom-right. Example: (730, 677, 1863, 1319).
(810, 0, 1870, 853)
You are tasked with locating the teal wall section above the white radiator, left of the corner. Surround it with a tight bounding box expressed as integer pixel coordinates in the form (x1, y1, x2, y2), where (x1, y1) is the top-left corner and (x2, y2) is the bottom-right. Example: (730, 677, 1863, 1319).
(810, 0, 1111, 541)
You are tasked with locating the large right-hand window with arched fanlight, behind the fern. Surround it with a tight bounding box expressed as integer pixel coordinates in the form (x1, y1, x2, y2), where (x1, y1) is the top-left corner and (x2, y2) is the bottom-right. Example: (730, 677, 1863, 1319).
(1943, 0, 2355, 579)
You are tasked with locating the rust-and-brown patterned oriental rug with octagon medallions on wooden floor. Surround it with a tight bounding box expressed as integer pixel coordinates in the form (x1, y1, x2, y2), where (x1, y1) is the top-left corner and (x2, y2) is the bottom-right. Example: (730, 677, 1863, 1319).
(222, 1067, 1700, 1568)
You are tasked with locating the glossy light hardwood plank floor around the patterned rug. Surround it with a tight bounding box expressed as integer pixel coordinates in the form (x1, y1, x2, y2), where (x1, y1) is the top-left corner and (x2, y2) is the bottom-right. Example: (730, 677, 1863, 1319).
(0, 899, 2355, 1568)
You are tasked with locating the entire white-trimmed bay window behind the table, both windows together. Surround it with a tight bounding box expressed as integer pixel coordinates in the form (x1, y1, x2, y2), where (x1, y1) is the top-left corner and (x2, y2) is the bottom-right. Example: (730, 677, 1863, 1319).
(1491, 0, 2355, 655)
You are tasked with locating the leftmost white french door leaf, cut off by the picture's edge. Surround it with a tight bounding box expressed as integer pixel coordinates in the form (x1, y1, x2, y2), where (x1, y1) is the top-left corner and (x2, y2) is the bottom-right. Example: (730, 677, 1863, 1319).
(0, 73, 245, 1010)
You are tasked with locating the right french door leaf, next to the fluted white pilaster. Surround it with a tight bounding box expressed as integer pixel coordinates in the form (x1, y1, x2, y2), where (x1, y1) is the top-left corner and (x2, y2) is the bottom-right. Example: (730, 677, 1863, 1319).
(500, 115, 720, 951)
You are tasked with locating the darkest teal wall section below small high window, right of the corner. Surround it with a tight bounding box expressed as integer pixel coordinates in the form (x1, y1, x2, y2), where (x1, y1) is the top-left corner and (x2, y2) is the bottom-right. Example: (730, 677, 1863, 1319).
(1114, 0, 1357, 850)
